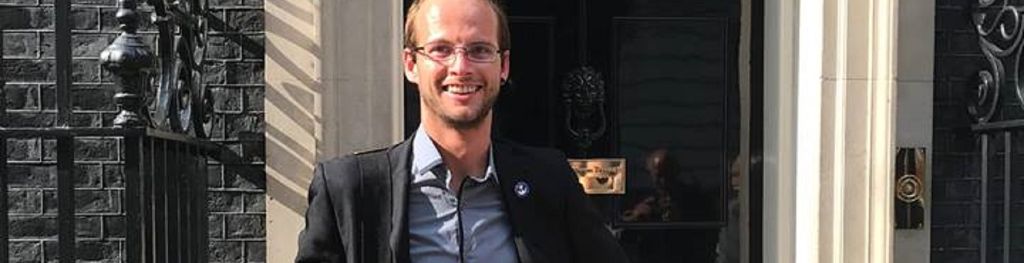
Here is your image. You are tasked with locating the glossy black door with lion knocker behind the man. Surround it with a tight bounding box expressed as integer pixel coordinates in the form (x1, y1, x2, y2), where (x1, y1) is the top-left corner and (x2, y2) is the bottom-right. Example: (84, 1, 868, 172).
(406, 0, 761, 260)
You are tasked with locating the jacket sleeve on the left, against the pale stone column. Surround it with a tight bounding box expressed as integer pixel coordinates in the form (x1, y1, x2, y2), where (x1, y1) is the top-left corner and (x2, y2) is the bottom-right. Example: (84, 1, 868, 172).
(295, 164, 345, 260)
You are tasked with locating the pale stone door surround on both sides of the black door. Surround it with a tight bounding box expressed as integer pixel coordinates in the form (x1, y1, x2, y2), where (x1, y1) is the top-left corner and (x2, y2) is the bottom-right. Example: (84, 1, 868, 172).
(265, 0, 913, 259)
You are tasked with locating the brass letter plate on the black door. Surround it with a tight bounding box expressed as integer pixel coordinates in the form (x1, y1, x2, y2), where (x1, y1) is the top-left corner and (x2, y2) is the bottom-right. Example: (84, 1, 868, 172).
(568, 158, 626, 194)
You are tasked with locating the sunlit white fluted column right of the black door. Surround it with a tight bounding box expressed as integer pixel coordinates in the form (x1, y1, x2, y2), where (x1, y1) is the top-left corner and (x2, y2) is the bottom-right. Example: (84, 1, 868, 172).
(764, 0, 897, 259)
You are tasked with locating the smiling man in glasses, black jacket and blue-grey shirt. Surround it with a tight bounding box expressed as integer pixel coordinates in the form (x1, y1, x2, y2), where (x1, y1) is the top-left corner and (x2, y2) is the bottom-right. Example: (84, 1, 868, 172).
(296, 0, 627, 259)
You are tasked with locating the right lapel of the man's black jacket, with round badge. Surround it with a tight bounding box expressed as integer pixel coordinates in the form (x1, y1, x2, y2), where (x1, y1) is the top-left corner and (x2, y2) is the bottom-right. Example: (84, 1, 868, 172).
(492, 139, 536, 263)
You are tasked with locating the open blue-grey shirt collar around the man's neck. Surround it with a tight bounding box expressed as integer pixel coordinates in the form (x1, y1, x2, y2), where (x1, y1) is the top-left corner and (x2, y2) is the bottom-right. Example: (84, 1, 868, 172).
(412, 125, 498, 182)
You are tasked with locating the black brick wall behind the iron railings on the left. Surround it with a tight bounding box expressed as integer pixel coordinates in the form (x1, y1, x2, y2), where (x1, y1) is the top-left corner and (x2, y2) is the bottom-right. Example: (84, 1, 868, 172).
(0, 0, 265, 259)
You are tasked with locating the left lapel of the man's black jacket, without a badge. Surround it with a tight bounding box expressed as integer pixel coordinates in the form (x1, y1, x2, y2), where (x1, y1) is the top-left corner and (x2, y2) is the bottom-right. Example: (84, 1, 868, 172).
(388, 138, 413, 260)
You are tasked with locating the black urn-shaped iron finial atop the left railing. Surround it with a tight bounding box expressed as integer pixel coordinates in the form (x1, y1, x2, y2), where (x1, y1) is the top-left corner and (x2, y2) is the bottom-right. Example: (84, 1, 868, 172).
(99, 0, 154, 127)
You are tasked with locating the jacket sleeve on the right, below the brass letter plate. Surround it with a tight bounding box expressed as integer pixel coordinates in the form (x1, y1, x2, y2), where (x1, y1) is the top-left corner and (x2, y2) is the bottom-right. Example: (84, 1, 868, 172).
(558, 154, 629, 263)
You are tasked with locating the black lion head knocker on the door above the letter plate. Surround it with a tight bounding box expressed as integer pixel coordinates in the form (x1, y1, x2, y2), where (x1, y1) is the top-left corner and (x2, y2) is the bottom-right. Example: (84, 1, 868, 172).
(562, 67, 607, 156)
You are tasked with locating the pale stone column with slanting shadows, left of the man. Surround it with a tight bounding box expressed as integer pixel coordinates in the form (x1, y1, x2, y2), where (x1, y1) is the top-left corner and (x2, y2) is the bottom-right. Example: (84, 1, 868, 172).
(264, 0, 403, 259)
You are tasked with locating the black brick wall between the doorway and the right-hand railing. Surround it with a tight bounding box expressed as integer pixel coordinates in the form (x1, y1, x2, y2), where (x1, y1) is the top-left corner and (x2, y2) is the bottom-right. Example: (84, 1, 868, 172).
(931, 0, 995, 260)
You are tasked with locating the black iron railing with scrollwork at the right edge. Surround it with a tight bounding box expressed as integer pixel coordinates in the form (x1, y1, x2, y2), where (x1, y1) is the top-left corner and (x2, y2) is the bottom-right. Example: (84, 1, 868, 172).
(968, 0, 1024, 260)
